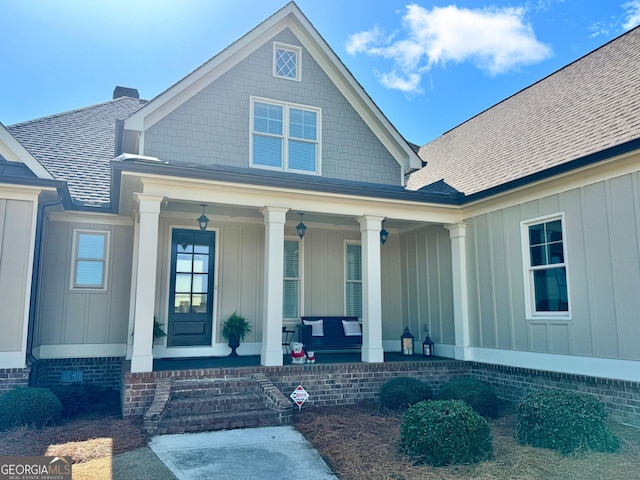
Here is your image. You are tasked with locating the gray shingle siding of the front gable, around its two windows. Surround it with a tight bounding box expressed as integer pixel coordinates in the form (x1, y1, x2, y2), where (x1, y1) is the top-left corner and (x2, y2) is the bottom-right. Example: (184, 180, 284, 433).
(144, 29, 402, 185)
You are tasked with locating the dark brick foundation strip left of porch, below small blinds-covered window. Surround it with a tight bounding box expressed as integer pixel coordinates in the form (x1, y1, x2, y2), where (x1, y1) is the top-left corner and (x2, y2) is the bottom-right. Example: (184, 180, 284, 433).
(36, 357, 124, 390)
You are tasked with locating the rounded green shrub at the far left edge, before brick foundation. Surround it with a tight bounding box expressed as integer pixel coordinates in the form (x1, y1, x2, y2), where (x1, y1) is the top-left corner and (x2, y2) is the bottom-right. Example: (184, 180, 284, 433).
(0, 388, 62, 431)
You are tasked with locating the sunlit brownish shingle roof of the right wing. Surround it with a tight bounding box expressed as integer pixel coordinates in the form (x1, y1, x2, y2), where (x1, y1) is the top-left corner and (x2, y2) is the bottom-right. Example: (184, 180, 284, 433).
(407, 27, 640, 195)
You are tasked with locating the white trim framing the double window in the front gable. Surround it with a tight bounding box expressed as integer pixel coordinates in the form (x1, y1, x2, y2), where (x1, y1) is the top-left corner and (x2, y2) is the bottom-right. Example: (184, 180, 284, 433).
(249, 95, 322, 175)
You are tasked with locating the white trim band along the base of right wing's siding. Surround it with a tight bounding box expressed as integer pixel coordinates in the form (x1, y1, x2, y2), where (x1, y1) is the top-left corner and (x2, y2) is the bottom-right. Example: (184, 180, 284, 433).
(469, 347, 640, 382)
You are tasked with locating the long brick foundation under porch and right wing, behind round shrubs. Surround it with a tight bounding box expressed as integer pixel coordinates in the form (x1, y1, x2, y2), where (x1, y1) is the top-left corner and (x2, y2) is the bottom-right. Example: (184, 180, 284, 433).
(120, 360, 640, 427)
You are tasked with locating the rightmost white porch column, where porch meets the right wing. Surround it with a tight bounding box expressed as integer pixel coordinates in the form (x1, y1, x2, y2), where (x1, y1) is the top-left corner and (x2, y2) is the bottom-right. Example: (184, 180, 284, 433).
(445, 223, 470, 360)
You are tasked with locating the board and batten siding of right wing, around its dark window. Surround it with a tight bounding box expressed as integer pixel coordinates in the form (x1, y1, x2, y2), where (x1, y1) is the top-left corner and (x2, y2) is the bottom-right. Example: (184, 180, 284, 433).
(465, 172, 640, 360)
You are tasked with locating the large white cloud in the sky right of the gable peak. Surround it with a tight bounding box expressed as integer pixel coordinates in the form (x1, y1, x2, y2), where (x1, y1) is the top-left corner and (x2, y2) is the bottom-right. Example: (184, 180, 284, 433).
(346, 0, 552, 93)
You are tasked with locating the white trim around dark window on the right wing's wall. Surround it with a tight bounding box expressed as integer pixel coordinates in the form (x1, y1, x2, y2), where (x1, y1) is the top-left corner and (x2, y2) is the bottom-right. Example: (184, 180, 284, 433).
(520, 212, 572, 321)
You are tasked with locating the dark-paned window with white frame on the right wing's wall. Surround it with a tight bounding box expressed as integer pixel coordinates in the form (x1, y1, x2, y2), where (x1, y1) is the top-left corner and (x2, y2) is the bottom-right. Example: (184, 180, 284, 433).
(522, 215, 569, 318)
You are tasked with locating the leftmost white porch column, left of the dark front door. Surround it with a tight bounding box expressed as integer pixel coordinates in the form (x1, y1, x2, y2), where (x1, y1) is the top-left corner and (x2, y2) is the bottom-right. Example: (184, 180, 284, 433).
(131, 193, 164, 373)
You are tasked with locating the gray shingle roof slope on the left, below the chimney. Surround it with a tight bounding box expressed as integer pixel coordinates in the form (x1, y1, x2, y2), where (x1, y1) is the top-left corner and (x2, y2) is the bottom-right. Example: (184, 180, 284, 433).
(7, 97, 146, 205)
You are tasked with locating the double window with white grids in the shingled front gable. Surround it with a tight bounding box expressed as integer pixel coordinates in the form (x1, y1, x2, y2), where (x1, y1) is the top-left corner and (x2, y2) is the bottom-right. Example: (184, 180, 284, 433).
(251, 98, 321, 174)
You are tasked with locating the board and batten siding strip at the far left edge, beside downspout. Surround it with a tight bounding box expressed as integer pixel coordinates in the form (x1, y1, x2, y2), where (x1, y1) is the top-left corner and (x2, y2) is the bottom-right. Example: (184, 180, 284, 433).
(0, 199, 35, 352)
